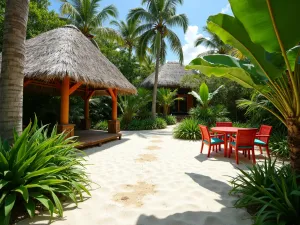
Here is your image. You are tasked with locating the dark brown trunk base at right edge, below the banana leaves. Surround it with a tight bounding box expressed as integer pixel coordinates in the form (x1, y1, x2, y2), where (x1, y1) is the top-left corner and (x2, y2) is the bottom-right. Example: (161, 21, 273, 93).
(287, 118, 300, 174)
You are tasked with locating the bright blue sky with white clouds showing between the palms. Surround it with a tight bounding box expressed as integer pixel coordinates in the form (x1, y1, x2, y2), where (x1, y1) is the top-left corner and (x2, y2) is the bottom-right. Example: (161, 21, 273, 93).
(49, 0, 231, 64)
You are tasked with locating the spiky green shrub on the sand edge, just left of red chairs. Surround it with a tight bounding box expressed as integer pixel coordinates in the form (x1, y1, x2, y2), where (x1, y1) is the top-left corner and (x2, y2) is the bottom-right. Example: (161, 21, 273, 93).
(173, 118, 206, 140)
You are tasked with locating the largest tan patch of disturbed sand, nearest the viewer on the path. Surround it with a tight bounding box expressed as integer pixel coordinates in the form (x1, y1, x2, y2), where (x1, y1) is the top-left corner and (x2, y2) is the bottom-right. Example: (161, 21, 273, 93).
(113, 182, 155, 207)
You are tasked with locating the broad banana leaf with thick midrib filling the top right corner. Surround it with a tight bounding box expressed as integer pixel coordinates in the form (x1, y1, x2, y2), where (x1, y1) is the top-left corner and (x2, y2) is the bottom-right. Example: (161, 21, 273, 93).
(229, 0, 300, 52)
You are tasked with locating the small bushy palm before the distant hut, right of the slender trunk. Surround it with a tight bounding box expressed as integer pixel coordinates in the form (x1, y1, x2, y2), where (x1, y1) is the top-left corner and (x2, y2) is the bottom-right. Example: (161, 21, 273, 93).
(157, 88, 183, 116)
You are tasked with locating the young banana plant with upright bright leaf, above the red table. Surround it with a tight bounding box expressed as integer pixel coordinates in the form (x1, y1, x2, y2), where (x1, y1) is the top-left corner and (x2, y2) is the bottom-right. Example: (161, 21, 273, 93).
(189, 83, 224, 109)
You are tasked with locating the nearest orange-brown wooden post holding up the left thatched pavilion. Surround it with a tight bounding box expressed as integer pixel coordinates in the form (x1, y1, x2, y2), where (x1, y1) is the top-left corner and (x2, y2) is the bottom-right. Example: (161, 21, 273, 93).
(60, 76, 70, 125)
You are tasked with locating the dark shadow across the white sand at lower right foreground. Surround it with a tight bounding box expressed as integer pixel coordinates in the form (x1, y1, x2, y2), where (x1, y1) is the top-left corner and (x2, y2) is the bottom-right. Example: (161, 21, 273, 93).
(136, 173, 252, 225)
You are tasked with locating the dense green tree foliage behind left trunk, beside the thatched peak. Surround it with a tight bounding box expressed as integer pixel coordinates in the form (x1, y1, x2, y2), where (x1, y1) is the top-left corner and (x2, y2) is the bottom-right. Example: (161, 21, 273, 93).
(0, 0, 66, 52)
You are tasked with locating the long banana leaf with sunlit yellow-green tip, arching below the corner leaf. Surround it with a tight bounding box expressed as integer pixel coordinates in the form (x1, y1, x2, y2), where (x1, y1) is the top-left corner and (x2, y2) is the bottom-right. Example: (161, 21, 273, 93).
(207, 14, 282, 81)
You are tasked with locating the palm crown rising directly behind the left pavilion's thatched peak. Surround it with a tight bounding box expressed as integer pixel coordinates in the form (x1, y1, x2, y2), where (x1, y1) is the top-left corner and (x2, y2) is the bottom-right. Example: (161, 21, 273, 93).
(60, 0, 119, 41)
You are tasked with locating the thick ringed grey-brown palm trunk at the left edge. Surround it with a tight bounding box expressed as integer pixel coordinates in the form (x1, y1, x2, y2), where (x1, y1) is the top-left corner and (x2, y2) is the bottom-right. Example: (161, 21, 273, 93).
(0, 0, 29, 141)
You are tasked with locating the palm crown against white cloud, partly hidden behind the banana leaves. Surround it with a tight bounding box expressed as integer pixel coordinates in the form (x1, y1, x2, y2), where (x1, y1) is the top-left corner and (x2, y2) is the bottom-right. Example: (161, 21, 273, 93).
(195, 26, 231, 57)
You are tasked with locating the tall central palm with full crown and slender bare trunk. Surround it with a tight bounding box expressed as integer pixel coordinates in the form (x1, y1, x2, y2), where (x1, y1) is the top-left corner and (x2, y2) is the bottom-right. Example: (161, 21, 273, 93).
(128, 0, 188, 118)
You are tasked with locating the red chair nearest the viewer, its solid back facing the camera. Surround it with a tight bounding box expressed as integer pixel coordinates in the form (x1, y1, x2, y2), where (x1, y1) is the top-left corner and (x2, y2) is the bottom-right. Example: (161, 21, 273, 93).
(229, 128, 257, 164)
